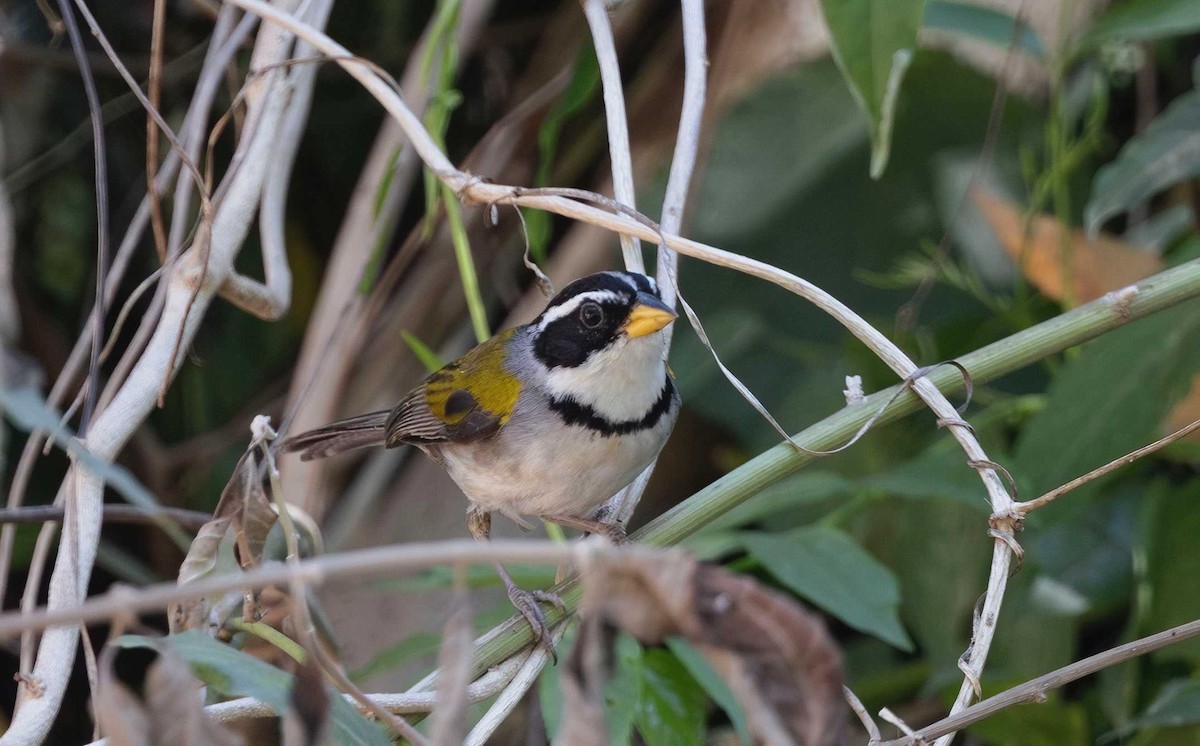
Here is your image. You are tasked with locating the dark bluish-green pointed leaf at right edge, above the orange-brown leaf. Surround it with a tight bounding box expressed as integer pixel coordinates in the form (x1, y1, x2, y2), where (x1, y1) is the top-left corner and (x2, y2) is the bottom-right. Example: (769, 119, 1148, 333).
(1084, 91, 1200, 234)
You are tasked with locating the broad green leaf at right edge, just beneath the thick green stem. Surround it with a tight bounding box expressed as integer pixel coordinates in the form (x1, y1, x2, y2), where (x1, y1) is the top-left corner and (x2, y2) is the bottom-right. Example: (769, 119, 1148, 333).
(1009, 301, 1200, 503)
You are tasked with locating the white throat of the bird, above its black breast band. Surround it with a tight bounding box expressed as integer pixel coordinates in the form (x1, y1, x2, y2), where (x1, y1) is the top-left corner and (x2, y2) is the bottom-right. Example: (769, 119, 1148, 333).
(546, 332, 667, 422)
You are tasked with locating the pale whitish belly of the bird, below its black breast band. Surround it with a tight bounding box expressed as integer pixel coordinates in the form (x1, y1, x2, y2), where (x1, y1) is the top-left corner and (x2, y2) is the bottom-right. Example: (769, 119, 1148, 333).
(439, 423, 670, 518)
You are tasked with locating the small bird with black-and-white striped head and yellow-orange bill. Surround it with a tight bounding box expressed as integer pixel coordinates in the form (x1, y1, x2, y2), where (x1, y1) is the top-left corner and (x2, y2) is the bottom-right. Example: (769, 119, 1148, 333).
(283, 271, 679, 648)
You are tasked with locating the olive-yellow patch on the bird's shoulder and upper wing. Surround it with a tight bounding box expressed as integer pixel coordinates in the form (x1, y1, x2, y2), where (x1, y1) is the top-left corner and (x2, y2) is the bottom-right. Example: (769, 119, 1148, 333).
(425, 329, 521, 425)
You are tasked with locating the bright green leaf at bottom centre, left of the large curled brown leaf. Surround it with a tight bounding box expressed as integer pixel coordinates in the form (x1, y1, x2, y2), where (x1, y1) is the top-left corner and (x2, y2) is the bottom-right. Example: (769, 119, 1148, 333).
(634, 648, 704, 746)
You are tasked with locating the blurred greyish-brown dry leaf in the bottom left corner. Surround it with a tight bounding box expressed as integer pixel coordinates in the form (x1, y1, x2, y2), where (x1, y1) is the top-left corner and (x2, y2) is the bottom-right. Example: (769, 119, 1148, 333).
(96, 648, 242, 746)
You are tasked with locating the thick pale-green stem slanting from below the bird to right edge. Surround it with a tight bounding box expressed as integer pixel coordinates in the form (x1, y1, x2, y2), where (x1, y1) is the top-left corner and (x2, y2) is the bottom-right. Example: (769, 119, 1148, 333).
(456, 259, 1200, 675)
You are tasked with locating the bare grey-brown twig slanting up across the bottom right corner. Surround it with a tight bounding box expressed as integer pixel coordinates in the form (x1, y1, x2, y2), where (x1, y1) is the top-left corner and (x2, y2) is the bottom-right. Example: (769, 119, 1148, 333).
(878, 619, 1200, 746)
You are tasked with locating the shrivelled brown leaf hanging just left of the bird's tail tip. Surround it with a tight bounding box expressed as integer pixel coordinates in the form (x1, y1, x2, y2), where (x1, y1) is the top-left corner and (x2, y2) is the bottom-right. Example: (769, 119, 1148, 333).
(168, 446, 277, 636)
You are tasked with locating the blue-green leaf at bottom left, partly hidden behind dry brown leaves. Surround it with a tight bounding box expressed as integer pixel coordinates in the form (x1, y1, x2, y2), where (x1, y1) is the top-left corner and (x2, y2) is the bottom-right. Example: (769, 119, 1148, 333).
(113, 631, 391, 746)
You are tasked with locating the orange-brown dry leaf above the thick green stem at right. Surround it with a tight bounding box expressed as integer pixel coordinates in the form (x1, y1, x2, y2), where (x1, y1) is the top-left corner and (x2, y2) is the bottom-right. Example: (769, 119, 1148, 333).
(971, 188, 1163, 303)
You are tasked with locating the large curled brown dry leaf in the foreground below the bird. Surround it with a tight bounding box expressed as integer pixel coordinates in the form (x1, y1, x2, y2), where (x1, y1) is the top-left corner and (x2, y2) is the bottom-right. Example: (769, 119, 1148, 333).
(576, 552, 846, 746)
